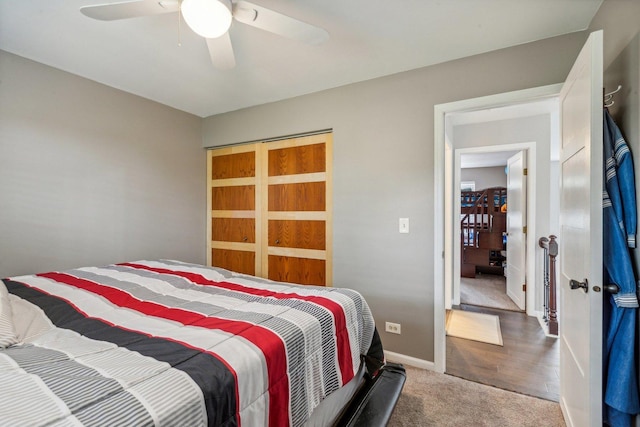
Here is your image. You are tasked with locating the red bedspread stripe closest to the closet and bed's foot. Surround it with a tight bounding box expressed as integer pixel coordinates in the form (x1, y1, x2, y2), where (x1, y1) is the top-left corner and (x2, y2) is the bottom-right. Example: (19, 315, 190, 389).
(118, 263, 354, 384)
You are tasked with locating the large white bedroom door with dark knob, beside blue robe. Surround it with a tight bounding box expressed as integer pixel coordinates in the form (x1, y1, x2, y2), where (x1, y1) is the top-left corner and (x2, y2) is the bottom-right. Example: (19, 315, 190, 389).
(558, 31, 602, 427)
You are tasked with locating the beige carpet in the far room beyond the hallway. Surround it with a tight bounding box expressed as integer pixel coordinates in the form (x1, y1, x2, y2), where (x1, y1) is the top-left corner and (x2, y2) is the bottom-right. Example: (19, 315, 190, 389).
(460, 274, 522, 311)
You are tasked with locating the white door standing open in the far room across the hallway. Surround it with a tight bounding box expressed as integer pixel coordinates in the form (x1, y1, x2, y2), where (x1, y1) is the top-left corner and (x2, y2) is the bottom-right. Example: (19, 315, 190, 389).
(507, 151, 527, 310)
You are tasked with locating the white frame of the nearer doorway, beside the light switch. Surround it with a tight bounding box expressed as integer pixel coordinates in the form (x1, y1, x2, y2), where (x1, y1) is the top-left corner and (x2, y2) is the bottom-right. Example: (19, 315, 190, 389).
(433, 84, 562, 372)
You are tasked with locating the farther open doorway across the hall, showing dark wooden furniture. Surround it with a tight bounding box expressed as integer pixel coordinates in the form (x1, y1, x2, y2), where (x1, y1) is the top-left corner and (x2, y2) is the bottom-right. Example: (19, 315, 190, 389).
(452, 149, 527, 311)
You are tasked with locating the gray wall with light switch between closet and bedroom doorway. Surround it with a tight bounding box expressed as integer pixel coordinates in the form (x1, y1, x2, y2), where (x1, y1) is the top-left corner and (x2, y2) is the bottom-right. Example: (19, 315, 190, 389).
(203, 33, 587, 361)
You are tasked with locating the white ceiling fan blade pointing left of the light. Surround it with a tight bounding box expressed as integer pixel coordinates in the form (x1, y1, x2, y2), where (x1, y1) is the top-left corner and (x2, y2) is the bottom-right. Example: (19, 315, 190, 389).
(80, 0, 180, 21)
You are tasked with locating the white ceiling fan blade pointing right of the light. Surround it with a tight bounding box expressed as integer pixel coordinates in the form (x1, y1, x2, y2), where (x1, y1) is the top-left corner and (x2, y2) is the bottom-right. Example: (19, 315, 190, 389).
(233, 0, 329, 45)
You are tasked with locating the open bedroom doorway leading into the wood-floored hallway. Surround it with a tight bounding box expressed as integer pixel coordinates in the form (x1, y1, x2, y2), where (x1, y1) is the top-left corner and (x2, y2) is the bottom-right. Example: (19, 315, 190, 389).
(436, 86, 559, 400)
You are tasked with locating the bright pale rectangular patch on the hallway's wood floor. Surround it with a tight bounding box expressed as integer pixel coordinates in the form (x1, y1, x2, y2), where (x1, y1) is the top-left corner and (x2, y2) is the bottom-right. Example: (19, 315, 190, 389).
(445, 310, 503, 345)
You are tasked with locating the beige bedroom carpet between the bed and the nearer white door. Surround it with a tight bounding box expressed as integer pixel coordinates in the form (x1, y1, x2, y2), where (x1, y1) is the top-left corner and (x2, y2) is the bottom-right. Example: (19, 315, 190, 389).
(388, 366, 565, 427)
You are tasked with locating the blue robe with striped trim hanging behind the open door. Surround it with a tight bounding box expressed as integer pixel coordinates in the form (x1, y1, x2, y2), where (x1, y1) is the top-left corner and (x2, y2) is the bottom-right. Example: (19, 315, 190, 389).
(602, 109, 640, 427)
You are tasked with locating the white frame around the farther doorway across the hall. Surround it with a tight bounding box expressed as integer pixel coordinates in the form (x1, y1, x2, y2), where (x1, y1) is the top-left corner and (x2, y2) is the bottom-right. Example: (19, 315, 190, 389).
(452, 141, 537, 310)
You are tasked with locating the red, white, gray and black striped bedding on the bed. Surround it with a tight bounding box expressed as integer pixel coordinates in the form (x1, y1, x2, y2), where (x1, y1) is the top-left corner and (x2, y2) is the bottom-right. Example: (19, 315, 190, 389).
(0, 260, 377, 427)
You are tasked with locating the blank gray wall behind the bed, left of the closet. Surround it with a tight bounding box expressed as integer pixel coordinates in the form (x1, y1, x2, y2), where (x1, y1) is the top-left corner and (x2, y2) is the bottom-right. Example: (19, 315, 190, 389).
(0, 51, 206, 277)
